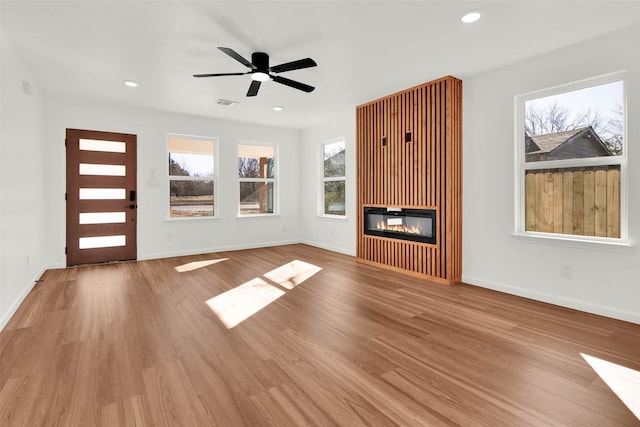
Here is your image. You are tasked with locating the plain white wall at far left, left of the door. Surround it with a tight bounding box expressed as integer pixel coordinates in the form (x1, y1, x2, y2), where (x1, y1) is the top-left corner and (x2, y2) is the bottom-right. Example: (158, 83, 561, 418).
(0, 34, 48, 329)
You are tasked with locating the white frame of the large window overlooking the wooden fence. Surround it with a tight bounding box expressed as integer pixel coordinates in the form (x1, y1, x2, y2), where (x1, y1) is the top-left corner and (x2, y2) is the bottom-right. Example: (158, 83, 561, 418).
(513, 71, 631, 247)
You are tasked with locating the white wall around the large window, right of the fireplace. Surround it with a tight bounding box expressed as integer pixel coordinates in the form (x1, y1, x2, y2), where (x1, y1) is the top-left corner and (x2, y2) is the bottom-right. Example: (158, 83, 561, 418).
(463, 27, 640, 323)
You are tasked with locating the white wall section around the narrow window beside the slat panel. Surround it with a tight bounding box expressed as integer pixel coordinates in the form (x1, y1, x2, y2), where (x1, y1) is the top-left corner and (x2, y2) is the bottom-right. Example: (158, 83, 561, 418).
(300, 106, 356, 255)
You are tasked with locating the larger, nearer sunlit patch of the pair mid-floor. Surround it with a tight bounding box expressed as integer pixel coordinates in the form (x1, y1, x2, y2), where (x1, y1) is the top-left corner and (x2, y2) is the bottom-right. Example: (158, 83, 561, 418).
(207, 277, 285, 329)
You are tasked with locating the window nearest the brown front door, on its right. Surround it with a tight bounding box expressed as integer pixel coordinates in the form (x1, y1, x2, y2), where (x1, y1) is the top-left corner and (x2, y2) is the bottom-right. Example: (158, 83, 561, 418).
(168, 135, 217, 218)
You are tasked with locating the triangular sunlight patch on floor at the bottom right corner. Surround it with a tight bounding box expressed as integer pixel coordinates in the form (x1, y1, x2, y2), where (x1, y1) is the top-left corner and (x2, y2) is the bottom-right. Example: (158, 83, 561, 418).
(580, 353, 640, 420)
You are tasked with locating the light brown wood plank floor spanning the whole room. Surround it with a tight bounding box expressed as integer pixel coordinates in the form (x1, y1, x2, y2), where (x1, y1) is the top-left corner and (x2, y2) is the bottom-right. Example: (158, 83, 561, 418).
(0, 245, 640, 427)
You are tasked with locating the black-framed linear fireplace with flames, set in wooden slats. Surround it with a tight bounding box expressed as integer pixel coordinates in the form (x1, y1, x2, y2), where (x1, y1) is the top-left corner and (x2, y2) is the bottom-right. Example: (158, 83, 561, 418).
(364, 207, 436, 244)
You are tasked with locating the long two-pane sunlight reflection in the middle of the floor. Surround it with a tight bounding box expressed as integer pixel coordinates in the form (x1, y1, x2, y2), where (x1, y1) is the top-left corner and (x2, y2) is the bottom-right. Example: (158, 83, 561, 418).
(206, 260, 322, 329)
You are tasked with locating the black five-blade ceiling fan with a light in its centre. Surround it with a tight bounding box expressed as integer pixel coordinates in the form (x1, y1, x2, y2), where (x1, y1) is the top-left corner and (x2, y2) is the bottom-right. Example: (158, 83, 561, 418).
(193, 47, 318, 96)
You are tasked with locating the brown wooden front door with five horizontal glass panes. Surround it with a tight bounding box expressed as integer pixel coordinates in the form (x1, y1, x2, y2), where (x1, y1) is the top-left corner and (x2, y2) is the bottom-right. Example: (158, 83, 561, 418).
(66, 129, 137, 266)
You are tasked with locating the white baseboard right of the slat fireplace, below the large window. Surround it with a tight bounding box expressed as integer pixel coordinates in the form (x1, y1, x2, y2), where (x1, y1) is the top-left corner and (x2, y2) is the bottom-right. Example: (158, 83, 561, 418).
(462, 274, 640, 324)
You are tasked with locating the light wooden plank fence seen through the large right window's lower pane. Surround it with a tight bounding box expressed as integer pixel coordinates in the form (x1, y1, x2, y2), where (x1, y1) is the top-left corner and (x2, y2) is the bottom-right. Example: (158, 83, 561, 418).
(525, 166, 620, 237)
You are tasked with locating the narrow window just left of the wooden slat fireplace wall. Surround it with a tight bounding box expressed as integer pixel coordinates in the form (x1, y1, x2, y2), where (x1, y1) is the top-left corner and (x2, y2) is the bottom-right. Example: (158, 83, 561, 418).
(321, 139, 346, 216)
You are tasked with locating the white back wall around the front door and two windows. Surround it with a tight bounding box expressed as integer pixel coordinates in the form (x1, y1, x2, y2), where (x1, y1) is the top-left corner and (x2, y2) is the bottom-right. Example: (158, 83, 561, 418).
(45, 99, 301, 266)
